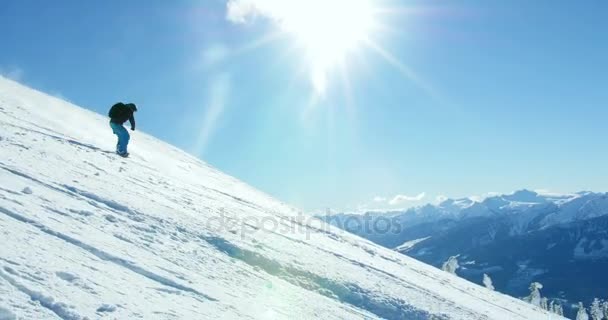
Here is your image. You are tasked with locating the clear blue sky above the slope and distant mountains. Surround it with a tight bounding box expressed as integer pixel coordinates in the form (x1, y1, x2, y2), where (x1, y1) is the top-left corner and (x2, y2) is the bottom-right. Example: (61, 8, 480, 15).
(0, 0, 608, 210)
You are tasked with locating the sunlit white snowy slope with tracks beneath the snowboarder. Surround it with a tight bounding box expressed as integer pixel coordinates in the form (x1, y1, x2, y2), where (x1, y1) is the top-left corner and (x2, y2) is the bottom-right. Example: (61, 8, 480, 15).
(0, 78, 558, 319)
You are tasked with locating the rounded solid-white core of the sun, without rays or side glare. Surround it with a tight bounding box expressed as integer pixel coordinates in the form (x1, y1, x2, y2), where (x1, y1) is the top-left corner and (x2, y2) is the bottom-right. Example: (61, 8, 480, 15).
(281, 0, 374, 94)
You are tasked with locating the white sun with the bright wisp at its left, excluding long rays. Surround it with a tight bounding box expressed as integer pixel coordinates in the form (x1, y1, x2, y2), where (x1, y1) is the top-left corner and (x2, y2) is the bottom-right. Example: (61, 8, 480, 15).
(227, 0, 392, 96)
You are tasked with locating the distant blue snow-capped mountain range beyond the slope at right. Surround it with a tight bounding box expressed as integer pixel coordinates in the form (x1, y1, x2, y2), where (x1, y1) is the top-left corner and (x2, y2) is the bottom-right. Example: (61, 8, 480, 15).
(324, 190, 608, 316)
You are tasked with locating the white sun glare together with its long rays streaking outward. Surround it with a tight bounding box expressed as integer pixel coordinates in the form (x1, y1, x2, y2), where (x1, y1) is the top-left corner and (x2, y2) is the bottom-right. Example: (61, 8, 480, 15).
(227, 0, 443, 108)
